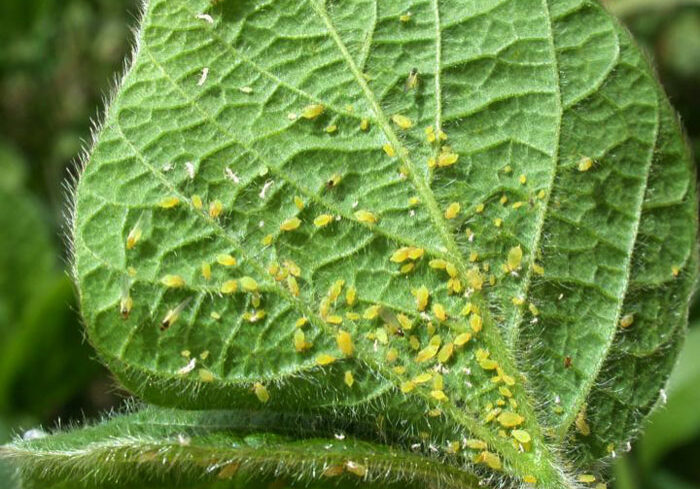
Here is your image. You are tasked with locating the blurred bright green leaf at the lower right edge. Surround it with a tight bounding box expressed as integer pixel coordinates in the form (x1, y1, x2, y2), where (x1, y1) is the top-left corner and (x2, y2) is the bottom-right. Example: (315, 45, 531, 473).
(639, 328, 700, 472)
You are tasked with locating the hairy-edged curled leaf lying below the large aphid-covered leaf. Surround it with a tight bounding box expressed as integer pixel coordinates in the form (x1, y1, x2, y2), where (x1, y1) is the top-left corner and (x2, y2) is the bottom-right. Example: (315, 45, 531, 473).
(2, 408, 477, 489)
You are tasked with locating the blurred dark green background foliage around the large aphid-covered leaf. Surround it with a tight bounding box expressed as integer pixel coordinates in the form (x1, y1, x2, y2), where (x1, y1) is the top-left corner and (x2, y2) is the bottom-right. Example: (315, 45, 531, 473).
(0, 0, 700, 489)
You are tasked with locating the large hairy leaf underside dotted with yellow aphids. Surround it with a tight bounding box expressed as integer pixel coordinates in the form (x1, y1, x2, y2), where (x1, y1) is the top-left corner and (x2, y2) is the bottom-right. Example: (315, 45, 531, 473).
(4, 0, 696, 487)
